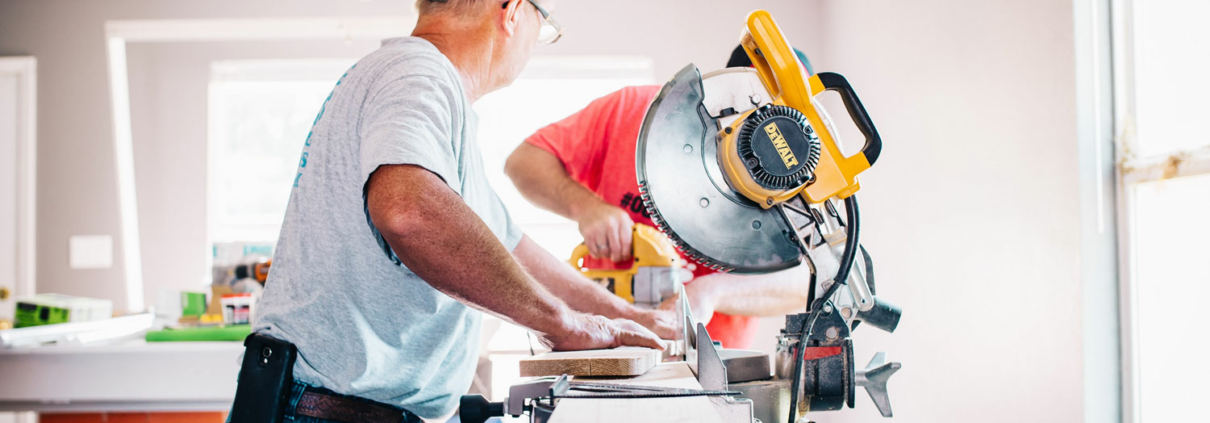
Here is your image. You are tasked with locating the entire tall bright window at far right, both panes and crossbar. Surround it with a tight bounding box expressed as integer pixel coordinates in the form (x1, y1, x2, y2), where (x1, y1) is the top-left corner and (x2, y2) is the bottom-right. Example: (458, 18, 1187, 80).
(1114, 0, 1210, 423)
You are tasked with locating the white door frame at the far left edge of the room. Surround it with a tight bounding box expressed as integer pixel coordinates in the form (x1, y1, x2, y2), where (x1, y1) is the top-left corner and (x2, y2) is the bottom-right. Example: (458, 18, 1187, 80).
(0, 56, 38, 300)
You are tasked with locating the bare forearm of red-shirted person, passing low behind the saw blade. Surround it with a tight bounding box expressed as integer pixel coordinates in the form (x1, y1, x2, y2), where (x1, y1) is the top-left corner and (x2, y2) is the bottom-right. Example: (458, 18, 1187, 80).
(686, 265, 811, 317)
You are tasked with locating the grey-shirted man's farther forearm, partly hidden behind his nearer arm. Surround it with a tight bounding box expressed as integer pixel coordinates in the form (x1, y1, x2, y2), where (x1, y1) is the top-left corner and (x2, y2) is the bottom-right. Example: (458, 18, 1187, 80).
(513, 237, 635, 319)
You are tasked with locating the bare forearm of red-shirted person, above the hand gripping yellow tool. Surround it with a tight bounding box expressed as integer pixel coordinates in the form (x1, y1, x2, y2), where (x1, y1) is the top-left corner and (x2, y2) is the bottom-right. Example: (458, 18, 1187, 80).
(505, 143, 604, 220)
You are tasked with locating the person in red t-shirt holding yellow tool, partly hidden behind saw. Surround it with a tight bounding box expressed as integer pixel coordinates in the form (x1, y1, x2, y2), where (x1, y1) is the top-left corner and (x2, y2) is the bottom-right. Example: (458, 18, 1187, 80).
(505, 47, 811, 348)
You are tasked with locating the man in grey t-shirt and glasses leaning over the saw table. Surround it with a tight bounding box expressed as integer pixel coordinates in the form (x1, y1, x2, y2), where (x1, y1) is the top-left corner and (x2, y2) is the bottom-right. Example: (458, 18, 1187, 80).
(255, 0, 675, 419)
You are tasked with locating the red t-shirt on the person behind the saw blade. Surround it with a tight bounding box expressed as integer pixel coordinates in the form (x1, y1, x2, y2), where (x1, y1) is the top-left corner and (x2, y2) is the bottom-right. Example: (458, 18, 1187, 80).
(525, 86, 756, 348)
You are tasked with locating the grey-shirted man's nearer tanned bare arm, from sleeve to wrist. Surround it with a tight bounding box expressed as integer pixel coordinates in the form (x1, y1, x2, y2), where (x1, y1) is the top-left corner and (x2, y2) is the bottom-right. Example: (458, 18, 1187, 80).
(367, 166, 572, 335)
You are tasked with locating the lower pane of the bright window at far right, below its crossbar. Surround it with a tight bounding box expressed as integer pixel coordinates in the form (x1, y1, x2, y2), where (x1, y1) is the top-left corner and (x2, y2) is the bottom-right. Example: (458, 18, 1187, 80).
(1130, 174, 1210, 422)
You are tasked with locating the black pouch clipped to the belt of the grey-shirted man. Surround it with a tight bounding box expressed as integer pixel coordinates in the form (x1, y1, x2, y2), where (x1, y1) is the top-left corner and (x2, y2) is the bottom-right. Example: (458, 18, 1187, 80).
(230, 334, 298, 423)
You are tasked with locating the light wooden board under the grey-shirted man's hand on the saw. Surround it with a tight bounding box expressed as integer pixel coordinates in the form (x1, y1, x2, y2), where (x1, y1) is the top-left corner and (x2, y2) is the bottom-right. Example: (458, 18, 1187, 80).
(520, 348, 663, 377)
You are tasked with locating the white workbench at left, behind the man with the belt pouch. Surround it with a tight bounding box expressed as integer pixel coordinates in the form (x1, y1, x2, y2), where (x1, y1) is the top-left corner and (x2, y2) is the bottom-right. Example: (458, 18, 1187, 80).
(0, 340, 243, 412)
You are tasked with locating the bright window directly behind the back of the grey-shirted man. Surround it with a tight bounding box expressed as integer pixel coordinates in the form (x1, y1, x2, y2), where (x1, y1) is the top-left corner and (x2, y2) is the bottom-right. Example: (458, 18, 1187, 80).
(208, 59, 353, 243)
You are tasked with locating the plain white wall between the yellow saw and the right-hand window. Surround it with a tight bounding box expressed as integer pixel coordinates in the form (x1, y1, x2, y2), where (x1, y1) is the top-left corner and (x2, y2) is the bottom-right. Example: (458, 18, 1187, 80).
(816, 0, 1084, 422)
